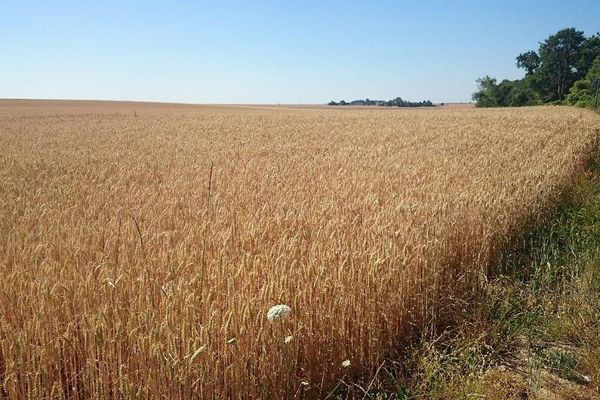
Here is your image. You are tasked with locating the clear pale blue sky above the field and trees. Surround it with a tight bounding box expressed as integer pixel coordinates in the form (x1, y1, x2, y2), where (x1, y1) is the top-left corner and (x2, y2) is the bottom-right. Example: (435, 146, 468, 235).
(0, 0, 600, 103)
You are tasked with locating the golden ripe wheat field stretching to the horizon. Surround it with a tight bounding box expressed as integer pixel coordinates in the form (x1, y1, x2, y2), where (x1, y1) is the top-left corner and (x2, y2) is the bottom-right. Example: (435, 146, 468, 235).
(0, 101, 600, 399)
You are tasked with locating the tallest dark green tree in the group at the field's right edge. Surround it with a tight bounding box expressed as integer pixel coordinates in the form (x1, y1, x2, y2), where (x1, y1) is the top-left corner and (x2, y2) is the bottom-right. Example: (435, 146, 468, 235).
(539, 28, 585, 101)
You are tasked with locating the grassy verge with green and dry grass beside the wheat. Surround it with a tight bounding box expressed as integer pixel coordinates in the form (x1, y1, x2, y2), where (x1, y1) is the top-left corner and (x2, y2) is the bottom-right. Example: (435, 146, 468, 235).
(338, 154, 600, 399)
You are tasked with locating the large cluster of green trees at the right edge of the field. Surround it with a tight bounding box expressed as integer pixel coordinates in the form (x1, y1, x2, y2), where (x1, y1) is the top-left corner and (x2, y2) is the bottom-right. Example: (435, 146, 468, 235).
(473, 28, 600, 107)
